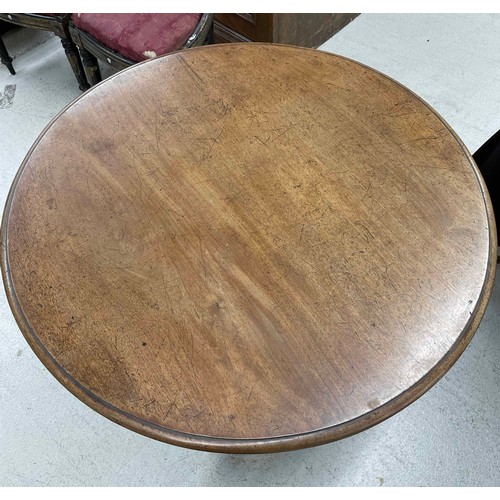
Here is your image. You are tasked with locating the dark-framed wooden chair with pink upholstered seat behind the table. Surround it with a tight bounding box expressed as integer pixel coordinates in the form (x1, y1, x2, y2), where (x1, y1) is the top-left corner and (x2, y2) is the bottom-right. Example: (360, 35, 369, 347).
(69, 14, 214, 85)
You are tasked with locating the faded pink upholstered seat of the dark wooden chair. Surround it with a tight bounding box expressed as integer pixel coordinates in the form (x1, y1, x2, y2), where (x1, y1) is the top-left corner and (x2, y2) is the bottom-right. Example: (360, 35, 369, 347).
(71, 14, 201, 61)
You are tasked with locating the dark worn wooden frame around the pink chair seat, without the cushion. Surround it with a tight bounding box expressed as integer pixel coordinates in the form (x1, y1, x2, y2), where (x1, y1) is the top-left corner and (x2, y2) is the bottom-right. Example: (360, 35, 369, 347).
(69, 14, 213, 85)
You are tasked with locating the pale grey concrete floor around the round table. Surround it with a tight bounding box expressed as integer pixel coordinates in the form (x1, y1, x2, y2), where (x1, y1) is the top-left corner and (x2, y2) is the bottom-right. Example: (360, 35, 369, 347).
(0, 14, 500, 486)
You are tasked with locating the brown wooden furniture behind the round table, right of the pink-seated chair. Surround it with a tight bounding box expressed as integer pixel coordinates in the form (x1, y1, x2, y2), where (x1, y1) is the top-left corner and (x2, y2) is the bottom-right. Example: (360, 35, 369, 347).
(214, 13, 359, 47)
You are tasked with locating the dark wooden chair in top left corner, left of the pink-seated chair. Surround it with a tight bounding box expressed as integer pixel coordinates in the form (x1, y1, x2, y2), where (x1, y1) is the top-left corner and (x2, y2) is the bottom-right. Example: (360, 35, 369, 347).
(0, 14, 90, 90)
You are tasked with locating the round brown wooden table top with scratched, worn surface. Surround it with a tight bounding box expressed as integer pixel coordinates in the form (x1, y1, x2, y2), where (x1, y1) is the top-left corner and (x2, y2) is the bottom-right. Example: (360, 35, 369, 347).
(2, 44, 496, 452)
